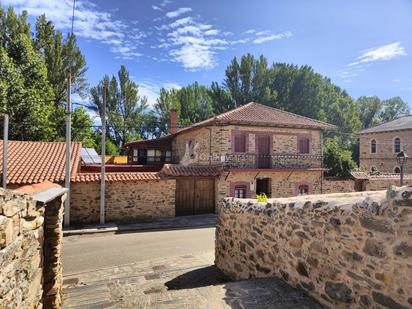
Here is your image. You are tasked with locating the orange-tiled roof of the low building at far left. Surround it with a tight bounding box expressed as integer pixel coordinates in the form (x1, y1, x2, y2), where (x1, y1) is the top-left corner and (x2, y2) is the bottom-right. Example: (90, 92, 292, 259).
(0, 140, 82, 185)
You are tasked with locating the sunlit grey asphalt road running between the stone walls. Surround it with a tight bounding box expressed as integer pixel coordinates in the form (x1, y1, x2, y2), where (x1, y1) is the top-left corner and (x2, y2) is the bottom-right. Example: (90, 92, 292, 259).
(63, 228, 215, 275)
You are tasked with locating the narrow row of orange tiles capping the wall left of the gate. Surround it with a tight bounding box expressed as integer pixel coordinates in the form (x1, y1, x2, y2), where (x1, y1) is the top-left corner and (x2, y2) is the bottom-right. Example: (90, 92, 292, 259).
(72, 172, 162, 182)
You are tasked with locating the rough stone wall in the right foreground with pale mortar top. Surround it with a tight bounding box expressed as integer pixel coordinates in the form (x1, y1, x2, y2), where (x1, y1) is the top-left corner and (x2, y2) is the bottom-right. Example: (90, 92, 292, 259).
(215, 187, 412, 308)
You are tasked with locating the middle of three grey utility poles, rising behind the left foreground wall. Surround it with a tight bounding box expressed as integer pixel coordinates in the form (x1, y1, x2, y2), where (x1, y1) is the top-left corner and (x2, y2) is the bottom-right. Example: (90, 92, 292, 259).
(64, 72, 72, 227)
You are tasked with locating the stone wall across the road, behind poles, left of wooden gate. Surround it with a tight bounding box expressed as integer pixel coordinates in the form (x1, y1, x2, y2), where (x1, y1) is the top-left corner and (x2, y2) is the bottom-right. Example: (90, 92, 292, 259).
(70, 179, 176, 224)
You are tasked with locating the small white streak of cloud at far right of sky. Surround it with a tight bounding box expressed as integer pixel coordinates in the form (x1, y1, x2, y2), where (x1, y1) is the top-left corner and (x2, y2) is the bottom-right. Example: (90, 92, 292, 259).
(348, 42, 407, 66)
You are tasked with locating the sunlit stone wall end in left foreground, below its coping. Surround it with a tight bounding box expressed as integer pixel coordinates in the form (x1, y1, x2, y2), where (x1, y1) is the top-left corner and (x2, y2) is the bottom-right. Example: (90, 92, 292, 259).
(0, 185, 64, 308)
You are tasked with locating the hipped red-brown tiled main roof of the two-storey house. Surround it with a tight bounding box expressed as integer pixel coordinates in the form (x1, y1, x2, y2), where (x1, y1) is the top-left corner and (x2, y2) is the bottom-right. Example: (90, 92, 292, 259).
(177, 102, 336, 134)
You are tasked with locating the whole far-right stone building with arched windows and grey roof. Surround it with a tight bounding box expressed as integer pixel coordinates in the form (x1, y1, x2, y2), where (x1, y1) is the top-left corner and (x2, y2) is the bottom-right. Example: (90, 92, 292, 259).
(359, 115, 412, 173)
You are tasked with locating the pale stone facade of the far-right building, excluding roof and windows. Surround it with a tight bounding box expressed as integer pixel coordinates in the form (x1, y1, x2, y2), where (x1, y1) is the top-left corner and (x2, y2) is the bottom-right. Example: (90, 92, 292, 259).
(359, 130, 412, 173)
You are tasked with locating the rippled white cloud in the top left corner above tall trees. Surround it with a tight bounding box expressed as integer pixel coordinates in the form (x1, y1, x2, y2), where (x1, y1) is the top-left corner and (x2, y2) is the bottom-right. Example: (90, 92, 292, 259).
(2, 0, 145, 59)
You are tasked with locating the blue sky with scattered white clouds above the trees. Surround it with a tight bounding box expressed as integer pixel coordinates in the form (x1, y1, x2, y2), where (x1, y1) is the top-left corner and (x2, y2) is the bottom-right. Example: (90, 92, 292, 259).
(0, 0, 412, 107)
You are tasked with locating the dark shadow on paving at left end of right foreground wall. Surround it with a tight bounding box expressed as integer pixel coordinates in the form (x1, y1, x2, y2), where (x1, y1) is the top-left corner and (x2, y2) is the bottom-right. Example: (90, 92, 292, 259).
(165, 265, 231, 290)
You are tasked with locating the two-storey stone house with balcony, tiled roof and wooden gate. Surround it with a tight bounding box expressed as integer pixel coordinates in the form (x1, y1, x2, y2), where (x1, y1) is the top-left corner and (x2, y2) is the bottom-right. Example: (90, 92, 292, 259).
(126, 102, 334, 215)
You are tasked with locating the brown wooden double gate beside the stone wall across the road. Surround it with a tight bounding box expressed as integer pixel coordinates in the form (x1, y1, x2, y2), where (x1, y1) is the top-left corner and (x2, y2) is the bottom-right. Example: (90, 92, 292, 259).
(175, 177, 215, 216)
